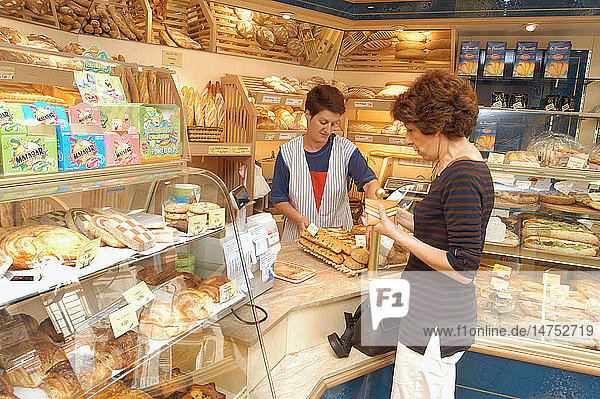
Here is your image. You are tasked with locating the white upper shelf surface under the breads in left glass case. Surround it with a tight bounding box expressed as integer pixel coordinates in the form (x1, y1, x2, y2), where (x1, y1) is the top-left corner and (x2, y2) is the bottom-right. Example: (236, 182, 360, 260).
(0, 223, 224, 306)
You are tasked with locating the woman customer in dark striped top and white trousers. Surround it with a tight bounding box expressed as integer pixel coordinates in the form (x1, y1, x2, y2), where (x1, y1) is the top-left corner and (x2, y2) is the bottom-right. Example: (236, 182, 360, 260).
(374, 71, 494, 399)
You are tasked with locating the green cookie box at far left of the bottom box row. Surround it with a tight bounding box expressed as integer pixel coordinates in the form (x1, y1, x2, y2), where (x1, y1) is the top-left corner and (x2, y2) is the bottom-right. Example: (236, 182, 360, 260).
(0, 126, 58, 176)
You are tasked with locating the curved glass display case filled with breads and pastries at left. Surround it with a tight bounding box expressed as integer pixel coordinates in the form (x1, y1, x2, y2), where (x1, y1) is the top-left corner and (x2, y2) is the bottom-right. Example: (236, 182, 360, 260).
(0, 163, 269, 398)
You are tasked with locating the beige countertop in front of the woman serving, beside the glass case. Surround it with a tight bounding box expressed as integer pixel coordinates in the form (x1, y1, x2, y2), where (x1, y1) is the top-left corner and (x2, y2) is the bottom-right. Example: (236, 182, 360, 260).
(219, 242, 366, 346)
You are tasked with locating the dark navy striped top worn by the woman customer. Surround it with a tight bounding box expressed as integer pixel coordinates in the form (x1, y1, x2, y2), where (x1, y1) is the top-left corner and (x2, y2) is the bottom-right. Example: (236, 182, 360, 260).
(399, 159, 494, 357)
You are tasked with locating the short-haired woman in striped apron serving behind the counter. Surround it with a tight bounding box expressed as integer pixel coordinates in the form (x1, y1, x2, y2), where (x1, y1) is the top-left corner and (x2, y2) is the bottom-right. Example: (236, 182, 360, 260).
(271, 85, 379, 242)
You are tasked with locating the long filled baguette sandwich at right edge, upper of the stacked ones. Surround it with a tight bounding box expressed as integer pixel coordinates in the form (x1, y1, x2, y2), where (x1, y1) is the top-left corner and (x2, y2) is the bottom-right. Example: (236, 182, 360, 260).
(521, 219, 600, 245)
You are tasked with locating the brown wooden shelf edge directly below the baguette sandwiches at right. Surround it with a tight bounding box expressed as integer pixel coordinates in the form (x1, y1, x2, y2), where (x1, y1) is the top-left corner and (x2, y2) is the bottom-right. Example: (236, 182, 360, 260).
(483, 243, 600, 269)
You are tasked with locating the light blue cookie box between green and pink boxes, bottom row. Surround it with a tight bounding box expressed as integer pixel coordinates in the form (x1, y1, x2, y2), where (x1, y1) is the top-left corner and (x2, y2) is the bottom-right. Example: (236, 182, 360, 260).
(58, 125, 106, 171)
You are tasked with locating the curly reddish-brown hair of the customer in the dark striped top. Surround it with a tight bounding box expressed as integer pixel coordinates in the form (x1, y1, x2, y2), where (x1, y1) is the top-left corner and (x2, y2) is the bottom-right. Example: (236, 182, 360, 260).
(391, 70, 479, 140)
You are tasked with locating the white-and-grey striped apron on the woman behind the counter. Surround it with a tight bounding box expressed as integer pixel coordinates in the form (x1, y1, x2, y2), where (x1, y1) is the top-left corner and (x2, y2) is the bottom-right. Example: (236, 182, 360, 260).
(280, 135, 356, 242)
